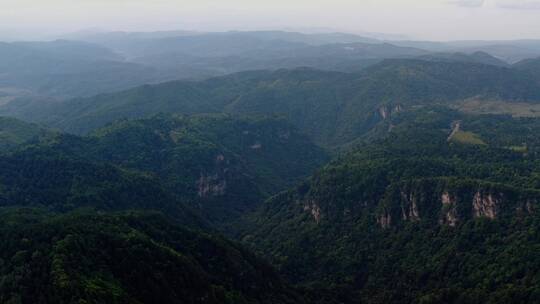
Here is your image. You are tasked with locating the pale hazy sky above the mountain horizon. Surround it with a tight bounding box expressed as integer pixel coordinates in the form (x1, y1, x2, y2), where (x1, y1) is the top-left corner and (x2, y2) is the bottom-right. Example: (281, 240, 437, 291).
(0, 0, 540, 40)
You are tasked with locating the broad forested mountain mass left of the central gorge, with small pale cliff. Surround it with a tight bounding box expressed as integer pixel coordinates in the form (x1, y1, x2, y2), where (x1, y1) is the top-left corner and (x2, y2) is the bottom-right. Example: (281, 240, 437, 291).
(0, 115, 327, 224)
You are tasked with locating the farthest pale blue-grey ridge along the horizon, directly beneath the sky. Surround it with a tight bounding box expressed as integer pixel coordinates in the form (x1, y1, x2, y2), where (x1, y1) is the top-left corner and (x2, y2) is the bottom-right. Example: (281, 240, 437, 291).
(68, 31, 380, 58)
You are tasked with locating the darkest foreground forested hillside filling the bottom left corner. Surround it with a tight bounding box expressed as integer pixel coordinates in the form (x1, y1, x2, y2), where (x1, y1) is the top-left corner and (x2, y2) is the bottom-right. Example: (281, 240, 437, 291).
(0, 209, 303, 304)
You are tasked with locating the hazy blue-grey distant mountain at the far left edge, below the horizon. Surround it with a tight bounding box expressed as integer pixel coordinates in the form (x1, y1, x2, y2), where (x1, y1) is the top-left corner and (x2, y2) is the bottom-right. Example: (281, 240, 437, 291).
(0, 41, 171, 97)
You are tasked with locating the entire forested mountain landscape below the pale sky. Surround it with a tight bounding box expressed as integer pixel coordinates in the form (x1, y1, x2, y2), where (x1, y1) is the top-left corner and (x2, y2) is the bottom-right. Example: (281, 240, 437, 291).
(0, 32, 540, 304)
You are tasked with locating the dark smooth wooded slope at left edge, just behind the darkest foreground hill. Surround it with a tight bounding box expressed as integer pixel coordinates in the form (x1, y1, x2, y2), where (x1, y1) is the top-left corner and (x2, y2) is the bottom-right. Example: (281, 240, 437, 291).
(0, 146, 206, 226)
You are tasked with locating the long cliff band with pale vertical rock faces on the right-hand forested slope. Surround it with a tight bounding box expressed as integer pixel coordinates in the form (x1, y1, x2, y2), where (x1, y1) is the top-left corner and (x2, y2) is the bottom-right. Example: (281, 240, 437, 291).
(376, 179, 540, 229)
